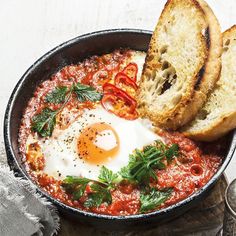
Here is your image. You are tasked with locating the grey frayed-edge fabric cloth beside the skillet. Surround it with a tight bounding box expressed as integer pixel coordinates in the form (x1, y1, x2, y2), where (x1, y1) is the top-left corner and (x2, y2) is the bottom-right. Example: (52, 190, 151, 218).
(0, 165, 59, 236)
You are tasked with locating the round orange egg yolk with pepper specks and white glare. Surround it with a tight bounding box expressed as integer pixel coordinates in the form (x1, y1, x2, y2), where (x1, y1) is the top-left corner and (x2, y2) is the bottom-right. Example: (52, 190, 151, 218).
(77, 122, 119, 164)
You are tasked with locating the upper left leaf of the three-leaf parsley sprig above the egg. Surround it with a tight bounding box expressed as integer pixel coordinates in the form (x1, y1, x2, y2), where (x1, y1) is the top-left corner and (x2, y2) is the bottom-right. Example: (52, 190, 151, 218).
(45, 86, 68, 104)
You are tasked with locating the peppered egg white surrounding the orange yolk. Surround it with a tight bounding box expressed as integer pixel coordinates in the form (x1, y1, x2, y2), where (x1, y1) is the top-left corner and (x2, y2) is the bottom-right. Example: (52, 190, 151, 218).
(36, 106, 160, 179)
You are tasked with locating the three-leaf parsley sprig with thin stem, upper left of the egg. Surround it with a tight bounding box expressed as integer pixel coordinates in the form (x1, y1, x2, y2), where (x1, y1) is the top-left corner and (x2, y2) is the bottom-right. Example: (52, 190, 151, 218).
(31, 83, 102, 137)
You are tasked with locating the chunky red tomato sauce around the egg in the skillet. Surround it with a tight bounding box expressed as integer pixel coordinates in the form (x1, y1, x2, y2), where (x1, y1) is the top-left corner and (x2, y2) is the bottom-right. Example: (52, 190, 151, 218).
(19, 50, 222, 215)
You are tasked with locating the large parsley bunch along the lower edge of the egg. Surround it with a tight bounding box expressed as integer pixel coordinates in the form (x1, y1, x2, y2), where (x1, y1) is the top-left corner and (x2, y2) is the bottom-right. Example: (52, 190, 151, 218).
(62, 141, 179, 213)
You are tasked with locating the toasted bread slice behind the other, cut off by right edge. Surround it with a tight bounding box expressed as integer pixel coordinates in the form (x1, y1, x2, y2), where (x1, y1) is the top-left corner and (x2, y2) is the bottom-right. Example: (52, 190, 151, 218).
(182, 25, 236, 141)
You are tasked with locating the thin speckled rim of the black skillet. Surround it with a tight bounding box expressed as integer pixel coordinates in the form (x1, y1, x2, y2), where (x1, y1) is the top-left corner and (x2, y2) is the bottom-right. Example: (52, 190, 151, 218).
(4, 28, 236, 221)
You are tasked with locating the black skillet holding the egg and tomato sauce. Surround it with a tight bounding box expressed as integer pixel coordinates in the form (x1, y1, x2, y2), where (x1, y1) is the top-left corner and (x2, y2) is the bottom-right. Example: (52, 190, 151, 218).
(4, 29, 236, 230)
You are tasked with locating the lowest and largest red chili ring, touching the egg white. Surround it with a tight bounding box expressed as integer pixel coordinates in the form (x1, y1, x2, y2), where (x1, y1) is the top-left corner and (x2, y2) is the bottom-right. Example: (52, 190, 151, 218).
(101, 93, 138, 120)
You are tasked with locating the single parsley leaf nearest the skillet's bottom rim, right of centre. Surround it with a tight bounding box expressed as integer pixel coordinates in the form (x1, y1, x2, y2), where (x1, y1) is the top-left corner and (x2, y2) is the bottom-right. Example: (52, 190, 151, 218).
(139, 188, 172, 213)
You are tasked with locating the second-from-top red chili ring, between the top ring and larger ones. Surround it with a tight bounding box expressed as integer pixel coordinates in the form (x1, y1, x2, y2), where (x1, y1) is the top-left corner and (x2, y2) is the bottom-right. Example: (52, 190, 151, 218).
(115, 72, 138, 92)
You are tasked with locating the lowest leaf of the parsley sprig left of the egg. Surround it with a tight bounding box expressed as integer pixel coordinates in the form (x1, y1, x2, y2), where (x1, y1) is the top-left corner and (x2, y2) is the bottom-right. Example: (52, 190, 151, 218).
(32, 107, 57, 137)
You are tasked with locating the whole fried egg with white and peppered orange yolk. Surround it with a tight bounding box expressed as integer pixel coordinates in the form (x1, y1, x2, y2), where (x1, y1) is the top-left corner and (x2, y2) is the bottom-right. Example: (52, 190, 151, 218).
(34, 106, 160, 179)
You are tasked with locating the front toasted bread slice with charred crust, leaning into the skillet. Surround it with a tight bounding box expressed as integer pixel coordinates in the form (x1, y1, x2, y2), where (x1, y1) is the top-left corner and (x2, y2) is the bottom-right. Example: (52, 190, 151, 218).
(137, 0, 222, 129)
